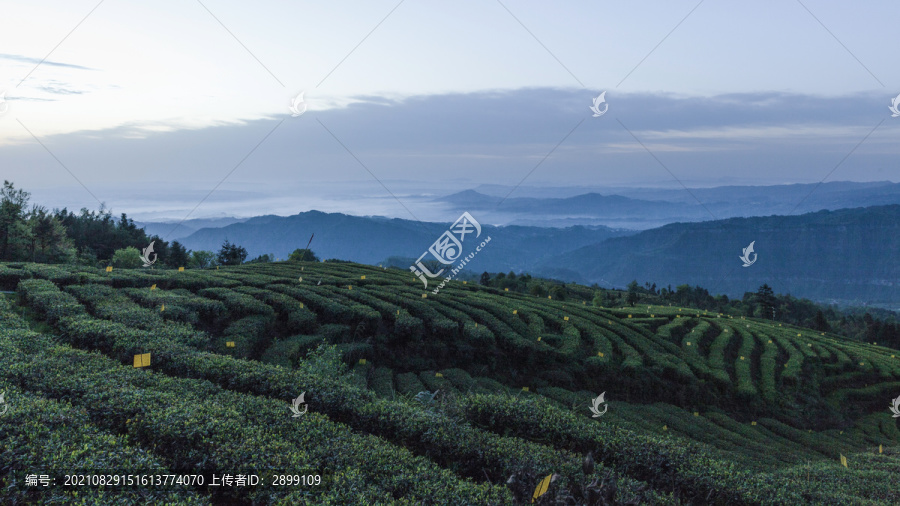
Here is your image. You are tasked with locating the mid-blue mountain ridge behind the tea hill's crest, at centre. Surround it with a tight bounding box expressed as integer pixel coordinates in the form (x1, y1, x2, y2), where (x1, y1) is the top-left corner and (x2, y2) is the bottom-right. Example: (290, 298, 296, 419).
(181, 211, 634, 272)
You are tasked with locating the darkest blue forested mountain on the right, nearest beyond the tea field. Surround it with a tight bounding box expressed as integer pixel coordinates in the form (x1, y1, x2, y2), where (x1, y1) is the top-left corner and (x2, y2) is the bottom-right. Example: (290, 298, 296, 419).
(533, 205, 900, 303)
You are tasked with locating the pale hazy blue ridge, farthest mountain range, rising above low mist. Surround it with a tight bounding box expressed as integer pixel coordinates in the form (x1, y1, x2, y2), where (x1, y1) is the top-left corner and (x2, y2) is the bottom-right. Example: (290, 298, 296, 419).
(437, 181, 900, 230)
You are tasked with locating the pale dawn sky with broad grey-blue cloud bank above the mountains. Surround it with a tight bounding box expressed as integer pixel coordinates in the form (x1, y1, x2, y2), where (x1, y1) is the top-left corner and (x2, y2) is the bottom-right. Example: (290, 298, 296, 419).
(0, 0, 900, 221)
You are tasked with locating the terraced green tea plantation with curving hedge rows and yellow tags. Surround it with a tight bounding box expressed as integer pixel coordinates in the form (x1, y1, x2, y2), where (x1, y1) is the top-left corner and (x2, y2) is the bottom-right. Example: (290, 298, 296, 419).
(0, 262, 900, 505)
